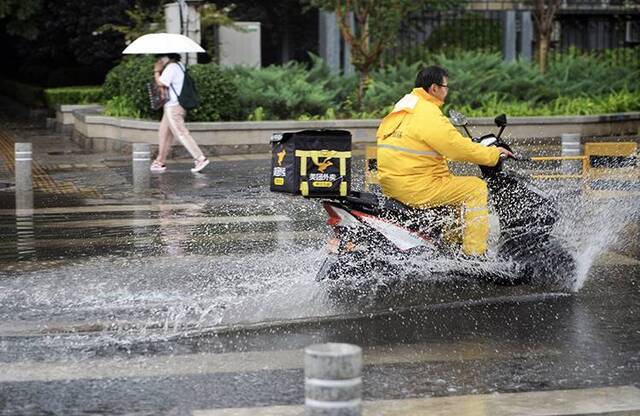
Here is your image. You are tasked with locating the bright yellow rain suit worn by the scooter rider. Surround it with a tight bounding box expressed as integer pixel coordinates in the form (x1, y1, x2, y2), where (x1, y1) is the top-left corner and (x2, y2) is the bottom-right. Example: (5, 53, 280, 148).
(376, 88, 500, 255)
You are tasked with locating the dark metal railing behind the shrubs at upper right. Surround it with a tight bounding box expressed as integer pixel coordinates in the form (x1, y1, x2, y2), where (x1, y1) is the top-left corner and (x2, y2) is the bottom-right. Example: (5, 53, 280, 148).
(385, 0, 640, 65)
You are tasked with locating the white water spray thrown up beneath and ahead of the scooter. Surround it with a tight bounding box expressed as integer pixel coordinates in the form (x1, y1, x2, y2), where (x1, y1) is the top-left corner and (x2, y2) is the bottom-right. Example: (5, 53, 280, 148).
(318, 177, 640, 296)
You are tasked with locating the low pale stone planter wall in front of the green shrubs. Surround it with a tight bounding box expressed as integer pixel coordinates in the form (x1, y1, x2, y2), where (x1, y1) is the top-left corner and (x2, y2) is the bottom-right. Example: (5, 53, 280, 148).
(56, 105, 640, 155)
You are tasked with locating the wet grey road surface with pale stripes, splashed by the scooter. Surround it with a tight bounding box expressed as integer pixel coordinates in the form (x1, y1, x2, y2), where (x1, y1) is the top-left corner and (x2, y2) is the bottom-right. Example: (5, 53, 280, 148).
(0, 115, 640, 415)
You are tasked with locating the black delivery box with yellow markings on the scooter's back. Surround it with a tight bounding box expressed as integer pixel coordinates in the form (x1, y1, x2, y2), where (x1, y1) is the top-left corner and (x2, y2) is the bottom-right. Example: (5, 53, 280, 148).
(270, 130, 351, 197)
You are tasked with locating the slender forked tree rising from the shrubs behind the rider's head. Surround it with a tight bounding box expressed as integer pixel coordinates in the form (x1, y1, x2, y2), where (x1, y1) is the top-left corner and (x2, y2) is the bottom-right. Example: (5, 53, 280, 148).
(310, 0, 419, 110)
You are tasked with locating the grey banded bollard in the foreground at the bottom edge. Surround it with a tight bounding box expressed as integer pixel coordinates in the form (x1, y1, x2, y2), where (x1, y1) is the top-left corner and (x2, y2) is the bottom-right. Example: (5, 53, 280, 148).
(305, 343, 362, 416)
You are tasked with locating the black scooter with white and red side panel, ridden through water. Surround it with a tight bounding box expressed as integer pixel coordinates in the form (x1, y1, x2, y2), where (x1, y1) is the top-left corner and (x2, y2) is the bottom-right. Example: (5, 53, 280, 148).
(316, 111, 575, 284)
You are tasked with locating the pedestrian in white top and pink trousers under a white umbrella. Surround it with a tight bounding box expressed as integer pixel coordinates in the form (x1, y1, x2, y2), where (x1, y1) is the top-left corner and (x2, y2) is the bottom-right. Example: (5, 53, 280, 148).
(122, 33, 209, 173)
